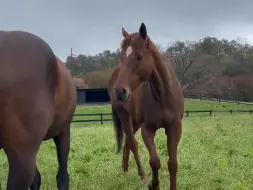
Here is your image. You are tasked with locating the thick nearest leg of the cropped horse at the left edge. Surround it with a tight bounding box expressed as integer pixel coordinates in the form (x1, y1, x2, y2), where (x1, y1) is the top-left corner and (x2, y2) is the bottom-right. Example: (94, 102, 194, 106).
(5, 148, 38, 190)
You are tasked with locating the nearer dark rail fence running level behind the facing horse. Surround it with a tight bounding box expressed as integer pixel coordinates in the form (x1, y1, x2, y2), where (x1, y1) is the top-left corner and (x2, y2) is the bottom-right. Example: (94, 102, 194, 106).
(72, 110, 253, 125)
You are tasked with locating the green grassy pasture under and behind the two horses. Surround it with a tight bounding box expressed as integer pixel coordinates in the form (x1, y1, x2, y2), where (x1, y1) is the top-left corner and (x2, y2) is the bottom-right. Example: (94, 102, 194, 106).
(0, 100, 253, 190)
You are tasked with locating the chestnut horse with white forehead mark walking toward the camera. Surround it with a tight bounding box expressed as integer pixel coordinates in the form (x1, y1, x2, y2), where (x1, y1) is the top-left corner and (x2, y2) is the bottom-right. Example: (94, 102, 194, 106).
(108, 23, 184, 190)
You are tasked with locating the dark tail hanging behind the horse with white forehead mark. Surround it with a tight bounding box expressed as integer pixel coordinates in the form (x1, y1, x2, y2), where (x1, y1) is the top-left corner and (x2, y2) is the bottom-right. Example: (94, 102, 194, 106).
(112, 106, 124, 153)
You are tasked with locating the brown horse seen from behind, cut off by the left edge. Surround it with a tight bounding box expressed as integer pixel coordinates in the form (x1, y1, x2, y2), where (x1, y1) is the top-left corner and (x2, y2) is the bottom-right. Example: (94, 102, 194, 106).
(0, 31, 76, 190)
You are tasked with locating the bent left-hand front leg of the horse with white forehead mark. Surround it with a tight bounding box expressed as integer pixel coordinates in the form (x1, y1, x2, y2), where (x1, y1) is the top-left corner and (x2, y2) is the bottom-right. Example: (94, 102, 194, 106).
(141, 126, 161, 190)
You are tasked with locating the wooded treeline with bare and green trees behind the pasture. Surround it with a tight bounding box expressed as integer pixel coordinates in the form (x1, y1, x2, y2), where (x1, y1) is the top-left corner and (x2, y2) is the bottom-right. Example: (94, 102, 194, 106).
(66, 36, 253, 101)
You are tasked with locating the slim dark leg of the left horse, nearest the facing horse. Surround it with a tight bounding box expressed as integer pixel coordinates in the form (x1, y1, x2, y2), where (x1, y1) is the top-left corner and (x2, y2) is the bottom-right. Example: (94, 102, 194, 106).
(54, 126, 70, 190)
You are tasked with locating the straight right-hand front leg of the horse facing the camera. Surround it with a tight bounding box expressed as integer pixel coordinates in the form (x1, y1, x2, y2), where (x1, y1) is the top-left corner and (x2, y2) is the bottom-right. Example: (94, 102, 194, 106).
(165, 120, 182, 190)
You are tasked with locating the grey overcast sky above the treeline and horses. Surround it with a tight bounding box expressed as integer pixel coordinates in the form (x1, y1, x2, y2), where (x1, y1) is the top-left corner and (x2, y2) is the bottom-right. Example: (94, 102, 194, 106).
(0, 0, 253, 60)
